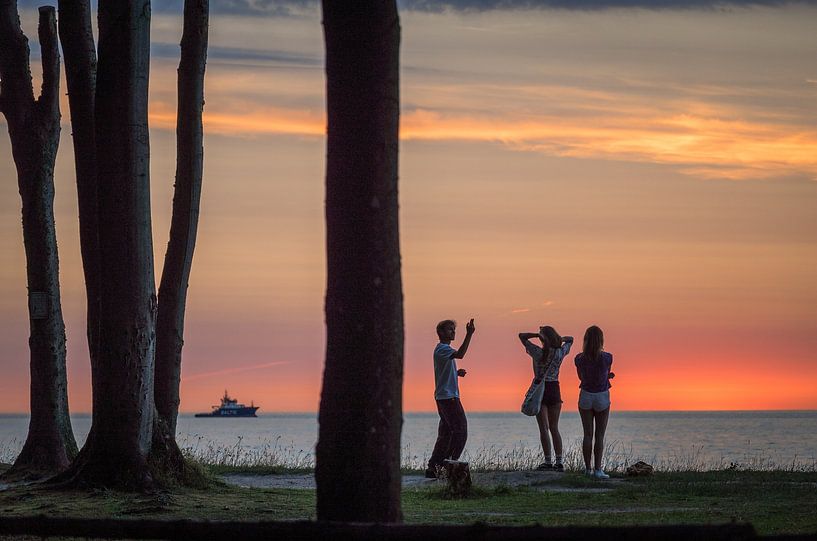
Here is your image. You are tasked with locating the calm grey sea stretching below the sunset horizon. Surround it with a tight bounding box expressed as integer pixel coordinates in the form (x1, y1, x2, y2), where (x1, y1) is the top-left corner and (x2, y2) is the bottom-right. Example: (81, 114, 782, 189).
(0, 410, 817, 471)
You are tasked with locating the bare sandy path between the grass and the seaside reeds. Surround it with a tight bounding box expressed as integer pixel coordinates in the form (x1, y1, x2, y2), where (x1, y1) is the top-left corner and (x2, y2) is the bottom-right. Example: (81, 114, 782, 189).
(222, 471, 624, 492)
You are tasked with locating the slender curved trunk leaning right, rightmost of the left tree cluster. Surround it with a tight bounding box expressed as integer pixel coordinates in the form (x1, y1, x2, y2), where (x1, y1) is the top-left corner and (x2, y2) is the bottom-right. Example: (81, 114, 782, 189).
(154, 0, 209, 435)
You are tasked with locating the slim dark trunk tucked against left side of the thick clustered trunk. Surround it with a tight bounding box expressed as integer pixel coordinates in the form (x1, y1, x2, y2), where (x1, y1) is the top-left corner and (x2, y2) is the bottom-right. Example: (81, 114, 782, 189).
(58, 0, 100, 416)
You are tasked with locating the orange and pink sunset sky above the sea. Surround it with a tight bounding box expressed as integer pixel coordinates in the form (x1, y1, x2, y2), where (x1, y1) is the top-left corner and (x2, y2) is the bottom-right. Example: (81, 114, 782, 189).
(0, 0, 817, 413)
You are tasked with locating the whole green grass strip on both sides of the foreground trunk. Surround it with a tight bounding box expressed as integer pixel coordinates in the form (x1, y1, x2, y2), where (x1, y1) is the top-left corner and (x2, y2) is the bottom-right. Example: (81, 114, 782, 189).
(0, 471, 817, 535)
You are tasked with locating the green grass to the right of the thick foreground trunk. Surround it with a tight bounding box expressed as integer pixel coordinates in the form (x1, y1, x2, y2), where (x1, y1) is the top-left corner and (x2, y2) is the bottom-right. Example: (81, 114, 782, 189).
(403, 472, 817, 535)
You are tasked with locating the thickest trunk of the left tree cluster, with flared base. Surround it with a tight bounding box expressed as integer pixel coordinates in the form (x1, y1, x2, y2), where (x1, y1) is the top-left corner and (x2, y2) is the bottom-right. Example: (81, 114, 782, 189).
(56, 0, 156, 489)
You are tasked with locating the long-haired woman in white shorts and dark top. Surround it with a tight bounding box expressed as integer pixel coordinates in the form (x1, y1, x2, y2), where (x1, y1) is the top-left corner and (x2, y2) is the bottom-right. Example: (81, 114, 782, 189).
(575, 325, 615, 479)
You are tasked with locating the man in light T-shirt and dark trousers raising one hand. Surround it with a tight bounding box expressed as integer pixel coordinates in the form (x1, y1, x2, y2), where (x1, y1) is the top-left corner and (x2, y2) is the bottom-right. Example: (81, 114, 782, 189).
(425, 318, 476, 479)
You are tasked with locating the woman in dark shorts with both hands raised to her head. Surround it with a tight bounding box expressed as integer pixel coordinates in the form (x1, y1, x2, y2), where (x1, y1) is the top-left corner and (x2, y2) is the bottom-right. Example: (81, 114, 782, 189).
(519, 326, 573, 471)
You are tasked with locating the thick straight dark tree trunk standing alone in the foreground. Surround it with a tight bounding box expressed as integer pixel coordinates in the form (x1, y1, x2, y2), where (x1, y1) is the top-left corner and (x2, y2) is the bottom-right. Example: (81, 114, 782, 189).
(315, 0, 403, 522)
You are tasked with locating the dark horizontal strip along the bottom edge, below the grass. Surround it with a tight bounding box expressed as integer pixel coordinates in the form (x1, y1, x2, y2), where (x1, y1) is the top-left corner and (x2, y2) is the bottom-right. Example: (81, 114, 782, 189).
(0, 516, 804, 541)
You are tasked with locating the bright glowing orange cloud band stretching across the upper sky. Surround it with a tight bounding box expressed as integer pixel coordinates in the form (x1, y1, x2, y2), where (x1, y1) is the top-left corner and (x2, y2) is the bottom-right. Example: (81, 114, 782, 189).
(151, 96, 817, 180)
